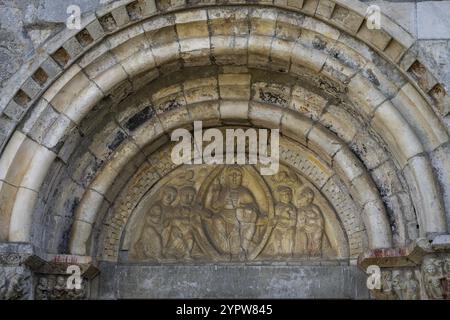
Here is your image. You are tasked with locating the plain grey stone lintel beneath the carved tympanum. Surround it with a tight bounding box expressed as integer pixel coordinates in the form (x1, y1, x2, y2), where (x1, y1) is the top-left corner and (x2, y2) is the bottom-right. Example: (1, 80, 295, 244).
(98, 265, 369, 299)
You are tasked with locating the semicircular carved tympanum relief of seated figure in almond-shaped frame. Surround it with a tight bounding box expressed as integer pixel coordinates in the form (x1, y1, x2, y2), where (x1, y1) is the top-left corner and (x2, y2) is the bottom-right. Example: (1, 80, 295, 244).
(122, 166, 342, 262)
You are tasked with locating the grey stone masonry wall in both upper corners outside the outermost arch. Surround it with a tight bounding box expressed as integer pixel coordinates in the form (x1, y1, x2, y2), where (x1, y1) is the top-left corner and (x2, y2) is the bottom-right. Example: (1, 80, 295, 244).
(0, 0, 450, 90)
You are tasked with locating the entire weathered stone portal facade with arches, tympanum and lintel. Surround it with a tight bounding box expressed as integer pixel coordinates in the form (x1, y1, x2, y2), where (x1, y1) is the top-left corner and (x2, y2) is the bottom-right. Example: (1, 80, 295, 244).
(0, 0, 450, 299)
